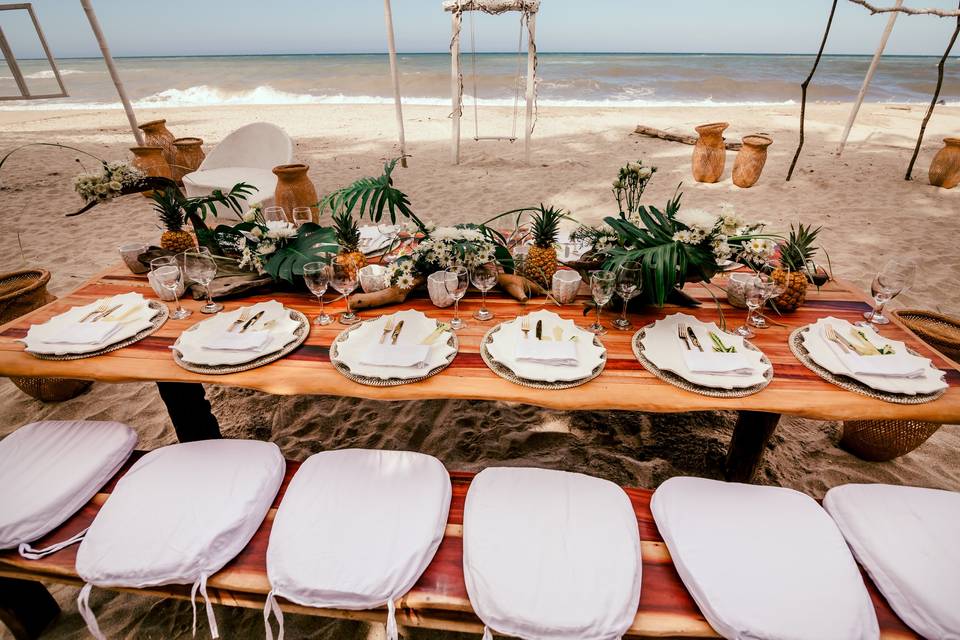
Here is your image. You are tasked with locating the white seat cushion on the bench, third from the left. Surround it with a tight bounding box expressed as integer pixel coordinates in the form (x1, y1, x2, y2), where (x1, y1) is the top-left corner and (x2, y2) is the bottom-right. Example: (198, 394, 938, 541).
(267, 449, 451, 636)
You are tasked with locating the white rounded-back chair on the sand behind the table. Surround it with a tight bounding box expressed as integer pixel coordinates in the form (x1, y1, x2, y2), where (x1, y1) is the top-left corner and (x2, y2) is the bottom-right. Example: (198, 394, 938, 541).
(183, 122, 293, 226)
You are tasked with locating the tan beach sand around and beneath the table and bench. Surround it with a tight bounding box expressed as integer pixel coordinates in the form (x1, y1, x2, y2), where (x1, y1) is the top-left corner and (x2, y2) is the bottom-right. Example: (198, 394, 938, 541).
(0, 104, 960, 639)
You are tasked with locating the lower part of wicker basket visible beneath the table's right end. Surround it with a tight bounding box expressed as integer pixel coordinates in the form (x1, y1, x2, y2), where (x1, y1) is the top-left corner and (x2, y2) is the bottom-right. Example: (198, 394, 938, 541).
(840, 420, 940, 462)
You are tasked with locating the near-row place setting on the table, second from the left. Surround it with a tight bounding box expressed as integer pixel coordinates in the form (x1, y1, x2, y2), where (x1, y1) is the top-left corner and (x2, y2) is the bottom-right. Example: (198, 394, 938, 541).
(170, 300, 310, 375)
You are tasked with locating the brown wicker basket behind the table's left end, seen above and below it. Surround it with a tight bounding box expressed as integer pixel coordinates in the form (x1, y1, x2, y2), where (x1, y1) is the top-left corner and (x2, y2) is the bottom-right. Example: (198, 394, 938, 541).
(0, 269, 92, 402)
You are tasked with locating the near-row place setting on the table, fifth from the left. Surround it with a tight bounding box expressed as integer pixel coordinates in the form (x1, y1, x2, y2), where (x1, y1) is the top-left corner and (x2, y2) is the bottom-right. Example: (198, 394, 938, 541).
(632, 313, 773, 398)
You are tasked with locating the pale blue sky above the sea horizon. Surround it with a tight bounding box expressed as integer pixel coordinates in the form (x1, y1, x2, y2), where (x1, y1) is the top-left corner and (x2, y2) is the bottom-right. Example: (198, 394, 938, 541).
(0, 0, 958, 58)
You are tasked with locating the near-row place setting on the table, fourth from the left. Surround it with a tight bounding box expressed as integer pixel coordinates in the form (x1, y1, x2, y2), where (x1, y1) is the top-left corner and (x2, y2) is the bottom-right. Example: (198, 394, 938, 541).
(480, 309, 607, 389)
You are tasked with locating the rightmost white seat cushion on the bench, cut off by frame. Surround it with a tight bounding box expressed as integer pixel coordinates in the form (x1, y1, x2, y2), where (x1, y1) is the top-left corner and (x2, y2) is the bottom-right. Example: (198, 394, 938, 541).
(823, 484, 960, 640)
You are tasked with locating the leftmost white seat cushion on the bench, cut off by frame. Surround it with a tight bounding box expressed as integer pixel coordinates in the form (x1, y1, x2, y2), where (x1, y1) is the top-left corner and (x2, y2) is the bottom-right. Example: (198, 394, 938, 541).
(0, 420, 137, 549)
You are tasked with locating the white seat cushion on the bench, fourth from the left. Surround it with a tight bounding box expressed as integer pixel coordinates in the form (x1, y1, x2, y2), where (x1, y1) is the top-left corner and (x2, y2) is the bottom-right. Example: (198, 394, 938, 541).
(463, 468, 641, 640)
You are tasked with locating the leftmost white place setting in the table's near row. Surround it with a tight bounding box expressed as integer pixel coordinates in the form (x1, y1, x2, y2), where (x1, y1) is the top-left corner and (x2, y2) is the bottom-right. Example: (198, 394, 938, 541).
(19, 292, 169, 360)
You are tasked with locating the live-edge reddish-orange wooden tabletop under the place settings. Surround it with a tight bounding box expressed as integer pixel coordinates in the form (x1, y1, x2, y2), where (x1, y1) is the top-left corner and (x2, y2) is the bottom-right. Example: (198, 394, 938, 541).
(0, 264, 960, 423)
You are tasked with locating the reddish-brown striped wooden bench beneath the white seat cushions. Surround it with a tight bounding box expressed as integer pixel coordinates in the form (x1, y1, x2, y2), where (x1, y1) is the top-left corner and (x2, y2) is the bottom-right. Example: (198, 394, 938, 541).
(0, 453, 919, 640)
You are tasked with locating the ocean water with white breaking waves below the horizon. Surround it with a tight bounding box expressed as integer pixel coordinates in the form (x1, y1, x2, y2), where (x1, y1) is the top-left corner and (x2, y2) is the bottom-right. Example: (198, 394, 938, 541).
(0, 53, 960, 109)
